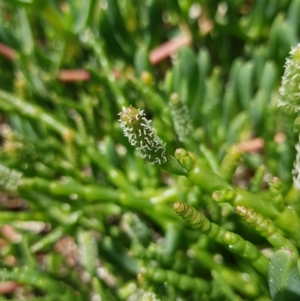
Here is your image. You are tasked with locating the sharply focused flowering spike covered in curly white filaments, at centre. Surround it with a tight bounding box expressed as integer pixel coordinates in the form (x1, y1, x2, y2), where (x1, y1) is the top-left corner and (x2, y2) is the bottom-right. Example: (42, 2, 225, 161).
(119, 106, 167, 165)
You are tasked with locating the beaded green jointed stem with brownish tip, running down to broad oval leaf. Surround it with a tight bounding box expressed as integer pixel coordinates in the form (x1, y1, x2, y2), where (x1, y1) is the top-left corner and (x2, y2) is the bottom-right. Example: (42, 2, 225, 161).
(173, 202, 269, 275)
